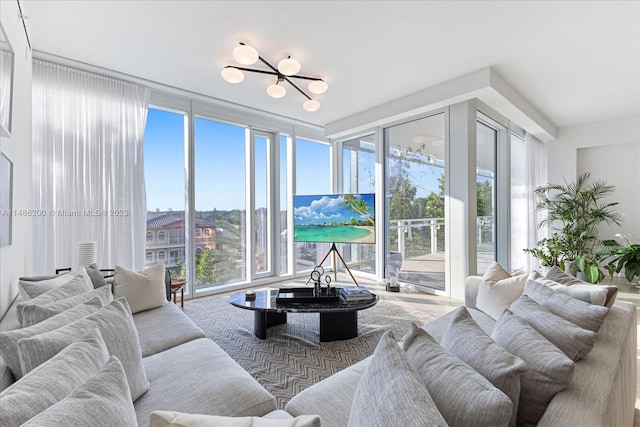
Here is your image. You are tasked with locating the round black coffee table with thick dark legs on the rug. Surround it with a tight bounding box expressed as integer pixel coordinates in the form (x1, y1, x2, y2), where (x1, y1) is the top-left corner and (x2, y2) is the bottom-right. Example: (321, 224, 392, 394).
(227, 289, 378, 342)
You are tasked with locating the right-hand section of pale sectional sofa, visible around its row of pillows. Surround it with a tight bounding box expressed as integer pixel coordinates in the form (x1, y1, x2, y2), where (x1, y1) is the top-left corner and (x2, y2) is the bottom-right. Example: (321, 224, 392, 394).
(285, 276, 637, 427)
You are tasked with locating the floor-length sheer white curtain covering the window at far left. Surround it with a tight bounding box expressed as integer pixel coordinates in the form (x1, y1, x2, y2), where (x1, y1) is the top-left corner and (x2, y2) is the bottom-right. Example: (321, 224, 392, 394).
(33, 60, 149, 274)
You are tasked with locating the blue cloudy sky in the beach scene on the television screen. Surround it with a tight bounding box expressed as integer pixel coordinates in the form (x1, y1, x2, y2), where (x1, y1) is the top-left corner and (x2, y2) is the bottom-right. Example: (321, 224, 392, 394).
(293, 194, 374, 224)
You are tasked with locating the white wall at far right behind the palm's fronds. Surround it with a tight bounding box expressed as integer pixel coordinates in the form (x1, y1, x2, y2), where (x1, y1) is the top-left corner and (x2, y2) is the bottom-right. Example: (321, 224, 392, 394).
(549, 116, 640, 246)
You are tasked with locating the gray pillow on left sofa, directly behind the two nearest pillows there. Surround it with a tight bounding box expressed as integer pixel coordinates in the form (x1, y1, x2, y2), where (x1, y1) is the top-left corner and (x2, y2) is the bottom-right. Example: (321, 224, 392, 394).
(18, 298, 149, 401)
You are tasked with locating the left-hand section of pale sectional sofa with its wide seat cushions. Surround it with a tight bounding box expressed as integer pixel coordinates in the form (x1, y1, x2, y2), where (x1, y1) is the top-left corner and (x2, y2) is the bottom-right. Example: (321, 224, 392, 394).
(0, 272, 280, 426)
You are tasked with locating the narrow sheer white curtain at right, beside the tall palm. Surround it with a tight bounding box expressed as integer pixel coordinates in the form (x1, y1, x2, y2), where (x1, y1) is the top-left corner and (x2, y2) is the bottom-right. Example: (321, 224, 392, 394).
(525, 133, 548, 270)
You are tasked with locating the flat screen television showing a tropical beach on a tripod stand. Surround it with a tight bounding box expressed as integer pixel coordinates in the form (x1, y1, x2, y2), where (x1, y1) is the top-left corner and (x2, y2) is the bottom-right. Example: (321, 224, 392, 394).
(293, 193, 376, 243)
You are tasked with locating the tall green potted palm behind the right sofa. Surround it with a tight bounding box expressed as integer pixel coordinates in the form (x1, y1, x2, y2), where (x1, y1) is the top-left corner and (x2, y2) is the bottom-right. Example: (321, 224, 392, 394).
(534, 172, 622, 282)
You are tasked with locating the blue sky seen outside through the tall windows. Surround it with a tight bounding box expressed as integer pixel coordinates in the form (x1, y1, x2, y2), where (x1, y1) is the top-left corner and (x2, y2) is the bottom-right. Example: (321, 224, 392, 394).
(144, 108, 458, 211)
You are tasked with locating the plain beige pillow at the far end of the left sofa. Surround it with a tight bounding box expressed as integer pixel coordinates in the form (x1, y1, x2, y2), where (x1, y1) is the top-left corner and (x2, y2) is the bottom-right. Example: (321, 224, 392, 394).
(113, 262, 167, 314)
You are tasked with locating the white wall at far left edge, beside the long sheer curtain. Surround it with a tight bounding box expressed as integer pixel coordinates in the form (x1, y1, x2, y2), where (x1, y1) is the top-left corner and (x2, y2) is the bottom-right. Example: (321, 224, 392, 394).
(0, 1, 33, 317)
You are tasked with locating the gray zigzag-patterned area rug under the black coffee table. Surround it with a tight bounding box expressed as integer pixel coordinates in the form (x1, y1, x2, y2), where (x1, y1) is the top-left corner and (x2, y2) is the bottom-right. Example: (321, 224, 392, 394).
(184, 297, 434, 409)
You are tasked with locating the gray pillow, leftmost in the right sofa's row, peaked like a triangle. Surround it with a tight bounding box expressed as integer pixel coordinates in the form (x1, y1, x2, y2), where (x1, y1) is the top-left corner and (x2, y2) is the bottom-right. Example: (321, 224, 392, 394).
(348, 332, 447, 427)
